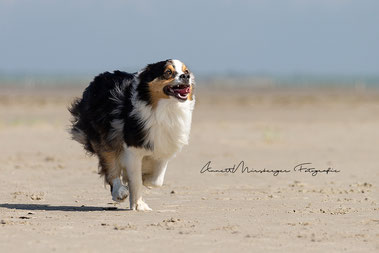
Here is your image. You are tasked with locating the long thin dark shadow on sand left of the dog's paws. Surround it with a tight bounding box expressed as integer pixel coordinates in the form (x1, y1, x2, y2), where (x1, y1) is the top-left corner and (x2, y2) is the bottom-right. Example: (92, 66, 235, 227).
(0, 203, 129, 212)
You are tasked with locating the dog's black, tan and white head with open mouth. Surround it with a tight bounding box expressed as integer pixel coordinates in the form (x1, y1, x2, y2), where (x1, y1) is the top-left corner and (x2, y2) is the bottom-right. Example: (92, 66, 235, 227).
(138, 60, 195, 106)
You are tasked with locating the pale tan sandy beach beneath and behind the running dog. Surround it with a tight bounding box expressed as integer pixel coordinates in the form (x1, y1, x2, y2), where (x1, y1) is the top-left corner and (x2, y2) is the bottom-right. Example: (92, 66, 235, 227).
(0, 87, 379, 252)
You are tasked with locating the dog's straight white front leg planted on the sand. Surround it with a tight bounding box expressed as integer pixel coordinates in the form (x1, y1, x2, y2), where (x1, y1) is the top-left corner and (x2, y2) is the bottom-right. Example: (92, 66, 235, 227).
(125, 149, 151, 211)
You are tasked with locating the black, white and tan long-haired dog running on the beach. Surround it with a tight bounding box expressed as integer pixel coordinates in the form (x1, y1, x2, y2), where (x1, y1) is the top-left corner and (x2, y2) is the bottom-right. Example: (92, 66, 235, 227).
(69, 59, 195, 211)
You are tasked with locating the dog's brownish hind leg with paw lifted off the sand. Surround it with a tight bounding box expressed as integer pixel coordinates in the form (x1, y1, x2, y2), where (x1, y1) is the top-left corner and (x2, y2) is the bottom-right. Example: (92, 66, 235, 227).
(98, 152, 129, 202)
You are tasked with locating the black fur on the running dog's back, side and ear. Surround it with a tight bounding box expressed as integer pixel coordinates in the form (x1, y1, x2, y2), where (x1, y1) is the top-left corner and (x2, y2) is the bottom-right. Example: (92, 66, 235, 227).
(69, 60, 173, 154)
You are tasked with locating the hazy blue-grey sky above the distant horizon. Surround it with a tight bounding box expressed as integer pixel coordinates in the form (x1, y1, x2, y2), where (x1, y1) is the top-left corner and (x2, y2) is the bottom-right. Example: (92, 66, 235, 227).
(0, 0, 379, 75)
